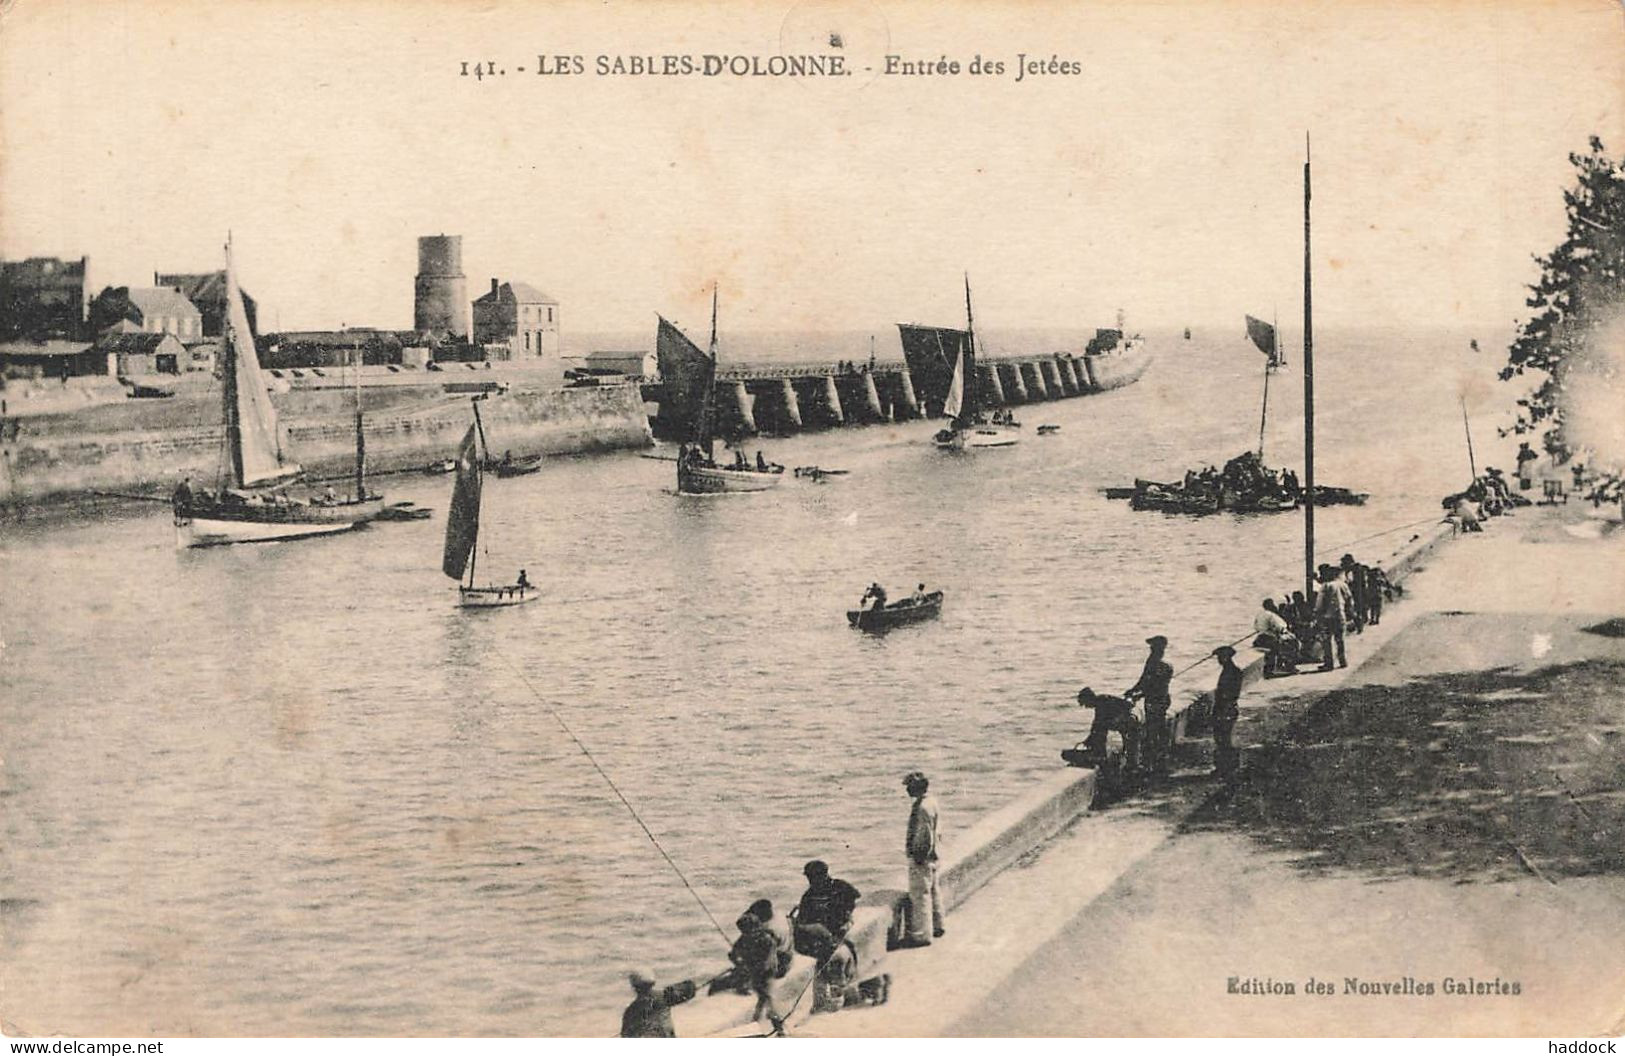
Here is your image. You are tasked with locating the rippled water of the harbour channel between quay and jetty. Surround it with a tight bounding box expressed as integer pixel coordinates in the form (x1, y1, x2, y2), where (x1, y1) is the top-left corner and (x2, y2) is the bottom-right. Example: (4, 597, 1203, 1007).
(0, 326, 1493, 1035)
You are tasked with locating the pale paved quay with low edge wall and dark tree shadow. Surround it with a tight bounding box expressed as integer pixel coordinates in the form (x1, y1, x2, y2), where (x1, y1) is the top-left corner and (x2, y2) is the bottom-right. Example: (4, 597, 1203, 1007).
(676, 507, 1625, 1037)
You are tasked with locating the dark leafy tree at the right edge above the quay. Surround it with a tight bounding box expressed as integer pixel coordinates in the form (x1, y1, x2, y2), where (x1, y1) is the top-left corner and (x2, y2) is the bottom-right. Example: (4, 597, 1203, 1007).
(1500, 136, 1625, 458)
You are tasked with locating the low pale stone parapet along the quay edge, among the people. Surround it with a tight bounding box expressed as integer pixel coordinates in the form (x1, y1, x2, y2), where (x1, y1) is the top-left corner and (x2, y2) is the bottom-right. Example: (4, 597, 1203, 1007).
(673, 513, 1453, 1037)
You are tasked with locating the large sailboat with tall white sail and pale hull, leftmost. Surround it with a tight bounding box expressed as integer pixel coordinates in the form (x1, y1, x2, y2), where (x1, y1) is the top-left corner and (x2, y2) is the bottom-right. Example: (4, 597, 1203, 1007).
(174, 233, 384, 546)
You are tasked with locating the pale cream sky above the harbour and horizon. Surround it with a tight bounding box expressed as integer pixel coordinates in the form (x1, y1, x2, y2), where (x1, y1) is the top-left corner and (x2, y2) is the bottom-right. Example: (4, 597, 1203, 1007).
(0, 0, 1625, 333)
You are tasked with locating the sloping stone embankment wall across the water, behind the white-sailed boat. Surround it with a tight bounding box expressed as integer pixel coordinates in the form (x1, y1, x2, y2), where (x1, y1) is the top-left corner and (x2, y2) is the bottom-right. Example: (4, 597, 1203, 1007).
(0, 385, 652, 507)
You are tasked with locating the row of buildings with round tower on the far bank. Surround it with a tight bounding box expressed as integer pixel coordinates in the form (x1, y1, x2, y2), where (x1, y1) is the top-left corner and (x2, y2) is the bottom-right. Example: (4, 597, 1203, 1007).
(0, 236, 562, 380)
